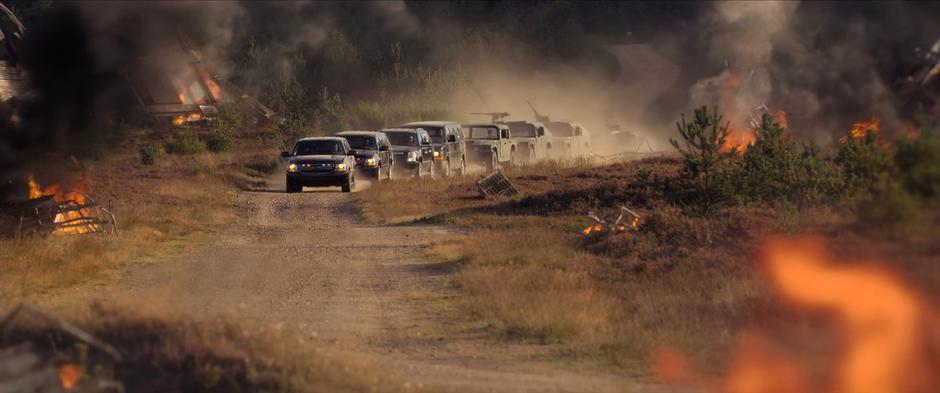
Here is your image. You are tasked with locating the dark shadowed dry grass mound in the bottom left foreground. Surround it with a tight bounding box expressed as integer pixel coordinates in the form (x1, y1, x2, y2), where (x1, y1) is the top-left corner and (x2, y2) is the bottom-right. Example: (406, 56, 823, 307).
(8, 305, 404, 392)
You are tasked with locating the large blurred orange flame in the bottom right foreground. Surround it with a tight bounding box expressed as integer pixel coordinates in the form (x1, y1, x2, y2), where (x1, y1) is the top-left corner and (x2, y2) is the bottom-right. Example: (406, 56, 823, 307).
(651, 238, 940, 393)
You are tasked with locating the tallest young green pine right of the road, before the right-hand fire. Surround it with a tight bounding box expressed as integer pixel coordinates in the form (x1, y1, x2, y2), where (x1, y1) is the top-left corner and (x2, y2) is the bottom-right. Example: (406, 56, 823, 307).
(667, 107, 737, 215)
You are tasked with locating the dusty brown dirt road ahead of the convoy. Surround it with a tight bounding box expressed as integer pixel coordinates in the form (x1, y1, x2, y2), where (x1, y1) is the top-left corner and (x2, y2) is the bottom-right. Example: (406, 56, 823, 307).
(127, 178, 668, 392)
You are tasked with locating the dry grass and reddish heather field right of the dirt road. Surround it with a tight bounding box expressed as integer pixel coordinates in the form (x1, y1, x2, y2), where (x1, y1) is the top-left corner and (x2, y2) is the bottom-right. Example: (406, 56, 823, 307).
(357, 158, 940, 376)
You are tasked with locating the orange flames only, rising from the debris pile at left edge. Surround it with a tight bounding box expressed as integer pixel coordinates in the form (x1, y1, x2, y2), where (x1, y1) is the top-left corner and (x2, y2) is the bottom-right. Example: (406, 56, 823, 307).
(26, 173, 94, 235)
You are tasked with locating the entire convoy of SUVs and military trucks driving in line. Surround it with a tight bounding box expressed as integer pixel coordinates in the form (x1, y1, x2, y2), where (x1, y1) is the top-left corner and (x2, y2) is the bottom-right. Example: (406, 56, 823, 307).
(282, 112, 591, 192)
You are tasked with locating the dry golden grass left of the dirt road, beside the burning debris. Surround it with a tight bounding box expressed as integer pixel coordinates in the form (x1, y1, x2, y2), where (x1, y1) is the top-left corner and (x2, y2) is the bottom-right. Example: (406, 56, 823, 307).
(0, 129, 276, 304)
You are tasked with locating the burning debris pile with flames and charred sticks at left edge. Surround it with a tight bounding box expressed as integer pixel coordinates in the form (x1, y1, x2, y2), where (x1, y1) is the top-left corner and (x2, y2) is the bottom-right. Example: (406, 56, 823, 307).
(0, 174, 118, 237)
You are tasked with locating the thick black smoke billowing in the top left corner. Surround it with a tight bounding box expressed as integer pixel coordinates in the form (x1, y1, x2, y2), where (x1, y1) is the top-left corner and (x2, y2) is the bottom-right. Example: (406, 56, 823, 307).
(0, 2, 240, 168)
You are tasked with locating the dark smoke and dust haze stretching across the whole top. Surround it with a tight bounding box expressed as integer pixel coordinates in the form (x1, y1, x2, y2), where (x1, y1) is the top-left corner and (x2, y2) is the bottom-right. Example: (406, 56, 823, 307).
(0, 1, 940, 165)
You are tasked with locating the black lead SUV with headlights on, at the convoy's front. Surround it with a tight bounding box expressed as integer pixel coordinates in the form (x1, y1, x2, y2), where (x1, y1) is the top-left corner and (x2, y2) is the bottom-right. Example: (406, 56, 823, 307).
(281, 137, 356, 192)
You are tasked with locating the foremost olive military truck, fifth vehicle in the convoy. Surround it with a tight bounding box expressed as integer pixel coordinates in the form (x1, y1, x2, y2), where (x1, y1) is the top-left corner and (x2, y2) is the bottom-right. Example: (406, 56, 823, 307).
(462, 123, 516, 171)
